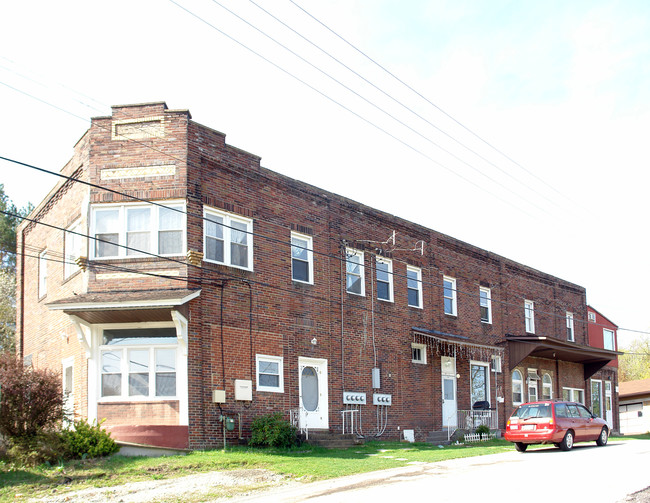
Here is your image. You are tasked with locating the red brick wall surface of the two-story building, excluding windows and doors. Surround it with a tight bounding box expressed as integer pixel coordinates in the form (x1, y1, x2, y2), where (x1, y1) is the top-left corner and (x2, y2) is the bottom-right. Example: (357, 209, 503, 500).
(19, 104, 586, 447)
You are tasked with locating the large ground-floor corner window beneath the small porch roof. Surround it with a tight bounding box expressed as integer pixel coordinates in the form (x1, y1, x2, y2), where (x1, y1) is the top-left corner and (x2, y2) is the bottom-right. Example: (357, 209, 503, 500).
(99, 326, 179, 401)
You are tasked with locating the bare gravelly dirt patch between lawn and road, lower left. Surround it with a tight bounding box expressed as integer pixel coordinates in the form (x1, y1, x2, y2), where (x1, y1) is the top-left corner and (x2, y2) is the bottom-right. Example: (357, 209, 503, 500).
(30, 469, 287, 503)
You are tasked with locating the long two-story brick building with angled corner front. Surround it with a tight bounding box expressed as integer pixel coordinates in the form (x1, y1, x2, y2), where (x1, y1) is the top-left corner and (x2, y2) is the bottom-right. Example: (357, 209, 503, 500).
(17, 103, 616, 448)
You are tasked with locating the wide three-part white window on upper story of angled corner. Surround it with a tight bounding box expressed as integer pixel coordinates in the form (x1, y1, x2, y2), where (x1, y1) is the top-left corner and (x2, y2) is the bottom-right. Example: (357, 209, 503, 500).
(90, 201, 186, 259)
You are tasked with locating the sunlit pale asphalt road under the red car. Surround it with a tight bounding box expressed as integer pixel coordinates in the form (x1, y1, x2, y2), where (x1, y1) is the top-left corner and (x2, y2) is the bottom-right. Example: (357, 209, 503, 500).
(229, 440, 650, 503)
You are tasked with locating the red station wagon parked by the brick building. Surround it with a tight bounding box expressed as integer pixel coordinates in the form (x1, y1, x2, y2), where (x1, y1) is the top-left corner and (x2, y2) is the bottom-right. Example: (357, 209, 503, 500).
(505, 400, 609, 452)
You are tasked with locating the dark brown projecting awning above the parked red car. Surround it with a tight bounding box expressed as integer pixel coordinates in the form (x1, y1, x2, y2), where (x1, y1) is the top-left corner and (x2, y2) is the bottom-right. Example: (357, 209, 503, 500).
(506, 334, 623, 381)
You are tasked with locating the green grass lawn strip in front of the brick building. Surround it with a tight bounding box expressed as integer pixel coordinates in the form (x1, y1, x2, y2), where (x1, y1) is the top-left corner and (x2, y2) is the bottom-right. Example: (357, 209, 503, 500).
(0, 440, 513, 501)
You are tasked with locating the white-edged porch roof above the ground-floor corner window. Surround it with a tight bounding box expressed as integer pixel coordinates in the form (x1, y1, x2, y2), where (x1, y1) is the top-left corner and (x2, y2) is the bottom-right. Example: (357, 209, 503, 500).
(47, 289, 201, 324)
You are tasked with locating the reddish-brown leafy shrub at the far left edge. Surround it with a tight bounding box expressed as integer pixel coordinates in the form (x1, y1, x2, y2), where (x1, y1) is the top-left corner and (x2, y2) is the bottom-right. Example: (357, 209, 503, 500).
(0, 352, 63, 440)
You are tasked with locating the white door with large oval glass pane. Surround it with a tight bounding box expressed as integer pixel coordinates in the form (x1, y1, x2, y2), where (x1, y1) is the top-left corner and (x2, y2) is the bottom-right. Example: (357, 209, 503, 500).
(298, 357, 329, 429)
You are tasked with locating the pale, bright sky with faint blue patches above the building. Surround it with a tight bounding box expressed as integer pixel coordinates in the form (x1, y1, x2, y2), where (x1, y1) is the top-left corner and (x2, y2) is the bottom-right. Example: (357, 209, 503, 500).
(0, 0, 650, 344)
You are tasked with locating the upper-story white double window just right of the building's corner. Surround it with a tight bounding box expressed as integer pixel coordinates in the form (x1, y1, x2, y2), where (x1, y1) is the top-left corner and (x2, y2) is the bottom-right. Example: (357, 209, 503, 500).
(203, 206, 253, 271)
